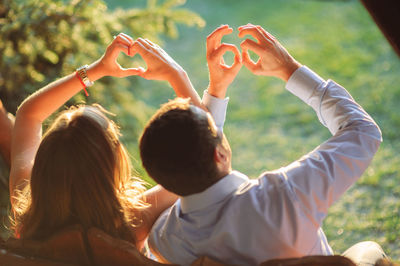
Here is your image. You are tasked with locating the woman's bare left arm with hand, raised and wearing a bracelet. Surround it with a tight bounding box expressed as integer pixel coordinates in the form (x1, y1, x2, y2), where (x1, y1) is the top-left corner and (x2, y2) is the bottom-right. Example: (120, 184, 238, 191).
(10, 33, 142, 207)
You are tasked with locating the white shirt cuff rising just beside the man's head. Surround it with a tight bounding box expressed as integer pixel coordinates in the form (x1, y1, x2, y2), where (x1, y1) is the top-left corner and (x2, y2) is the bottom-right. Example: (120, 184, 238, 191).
(202, 90, 229, 130)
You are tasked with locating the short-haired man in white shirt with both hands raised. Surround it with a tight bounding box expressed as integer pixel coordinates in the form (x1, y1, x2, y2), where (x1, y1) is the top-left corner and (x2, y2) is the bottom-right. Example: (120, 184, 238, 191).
(140, 24, 381, 265)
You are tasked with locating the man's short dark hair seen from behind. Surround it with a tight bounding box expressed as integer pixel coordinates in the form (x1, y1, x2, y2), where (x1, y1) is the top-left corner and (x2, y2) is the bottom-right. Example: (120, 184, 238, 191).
(139, 98, 221, 196)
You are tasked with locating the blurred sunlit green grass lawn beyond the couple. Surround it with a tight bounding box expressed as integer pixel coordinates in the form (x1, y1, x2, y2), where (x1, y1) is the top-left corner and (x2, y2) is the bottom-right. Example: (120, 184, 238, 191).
(104, 0, 400, 260)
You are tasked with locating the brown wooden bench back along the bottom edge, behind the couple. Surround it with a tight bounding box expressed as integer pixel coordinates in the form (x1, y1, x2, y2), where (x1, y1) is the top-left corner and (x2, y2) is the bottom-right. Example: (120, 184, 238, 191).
(0, 225, 355, 266)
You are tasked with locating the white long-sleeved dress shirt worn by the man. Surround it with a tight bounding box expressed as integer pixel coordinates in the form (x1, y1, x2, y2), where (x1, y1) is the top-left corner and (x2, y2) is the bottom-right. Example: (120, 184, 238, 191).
(148, 66, 381, 265)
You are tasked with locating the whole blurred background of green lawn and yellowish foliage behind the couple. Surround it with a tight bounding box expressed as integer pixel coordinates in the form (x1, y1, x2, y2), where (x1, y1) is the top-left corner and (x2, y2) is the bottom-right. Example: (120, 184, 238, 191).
(0, 0, 400, 260)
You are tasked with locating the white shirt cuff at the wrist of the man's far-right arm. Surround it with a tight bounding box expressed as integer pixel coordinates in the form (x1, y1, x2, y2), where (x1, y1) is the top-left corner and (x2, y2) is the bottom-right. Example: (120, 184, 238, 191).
(286, 66, 325, 104)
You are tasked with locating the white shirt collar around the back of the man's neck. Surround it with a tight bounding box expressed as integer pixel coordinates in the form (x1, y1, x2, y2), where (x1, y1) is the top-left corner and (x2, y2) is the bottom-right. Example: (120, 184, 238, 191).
(181, 171, 249, 213)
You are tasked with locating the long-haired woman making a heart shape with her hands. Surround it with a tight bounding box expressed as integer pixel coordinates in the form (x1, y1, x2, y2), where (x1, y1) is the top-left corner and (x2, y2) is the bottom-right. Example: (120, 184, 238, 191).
(10, 33, 201, 249)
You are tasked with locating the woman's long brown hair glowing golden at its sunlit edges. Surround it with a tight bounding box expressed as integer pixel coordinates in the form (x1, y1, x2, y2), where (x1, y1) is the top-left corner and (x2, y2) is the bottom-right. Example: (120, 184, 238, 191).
(13, 105, 147, 241)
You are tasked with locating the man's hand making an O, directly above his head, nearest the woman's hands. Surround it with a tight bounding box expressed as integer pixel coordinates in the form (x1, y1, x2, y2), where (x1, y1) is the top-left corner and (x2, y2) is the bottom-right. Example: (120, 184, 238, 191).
(207, 25, 242, 98)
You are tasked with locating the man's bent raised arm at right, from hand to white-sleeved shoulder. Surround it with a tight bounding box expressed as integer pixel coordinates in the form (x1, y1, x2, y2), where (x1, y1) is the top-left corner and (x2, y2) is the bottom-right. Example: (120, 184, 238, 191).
(239, 24, 382, 225)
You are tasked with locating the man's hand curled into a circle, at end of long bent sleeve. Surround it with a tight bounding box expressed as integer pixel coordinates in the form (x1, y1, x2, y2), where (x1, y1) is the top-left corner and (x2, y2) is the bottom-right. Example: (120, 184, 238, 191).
(238, 24, 301, 82)
